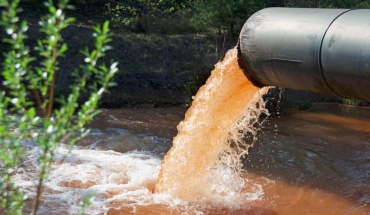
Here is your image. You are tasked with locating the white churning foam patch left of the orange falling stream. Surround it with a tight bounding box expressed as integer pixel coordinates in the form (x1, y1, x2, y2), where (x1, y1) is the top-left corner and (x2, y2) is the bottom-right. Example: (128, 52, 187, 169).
(14, 145, 189, 214)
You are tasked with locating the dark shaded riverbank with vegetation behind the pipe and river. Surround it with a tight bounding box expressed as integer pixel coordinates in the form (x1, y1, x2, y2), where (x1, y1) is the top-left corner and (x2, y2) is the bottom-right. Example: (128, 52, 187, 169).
(0, 0, 370, 107)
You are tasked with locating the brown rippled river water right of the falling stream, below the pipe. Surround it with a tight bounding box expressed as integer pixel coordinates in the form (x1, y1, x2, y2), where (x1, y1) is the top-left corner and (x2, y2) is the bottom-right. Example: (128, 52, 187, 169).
(243, 104, 370, 214)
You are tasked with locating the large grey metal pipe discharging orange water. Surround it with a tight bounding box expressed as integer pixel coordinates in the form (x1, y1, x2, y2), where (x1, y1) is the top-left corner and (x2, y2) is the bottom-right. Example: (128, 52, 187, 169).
(238, 8, 370, 101)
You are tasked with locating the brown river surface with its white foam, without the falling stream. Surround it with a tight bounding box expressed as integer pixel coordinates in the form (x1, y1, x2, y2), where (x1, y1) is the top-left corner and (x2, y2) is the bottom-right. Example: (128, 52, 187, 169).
(16, 104, 370, 215)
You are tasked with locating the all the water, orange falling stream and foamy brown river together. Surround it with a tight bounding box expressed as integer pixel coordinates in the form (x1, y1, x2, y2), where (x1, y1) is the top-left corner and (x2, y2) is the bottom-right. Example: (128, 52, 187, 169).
(14, 50, 370, 215)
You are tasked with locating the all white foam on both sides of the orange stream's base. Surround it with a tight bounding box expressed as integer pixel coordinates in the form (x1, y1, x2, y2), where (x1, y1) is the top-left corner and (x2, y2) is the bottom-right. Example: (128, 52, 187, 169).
(14, 138, 263, 215)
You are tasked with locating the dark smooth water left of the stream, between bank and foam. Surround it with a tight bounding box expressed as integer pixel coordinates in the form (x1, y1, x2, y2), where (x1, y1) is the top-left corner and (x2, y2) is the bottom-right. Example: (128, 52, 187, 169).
(77, 107, 186, 157)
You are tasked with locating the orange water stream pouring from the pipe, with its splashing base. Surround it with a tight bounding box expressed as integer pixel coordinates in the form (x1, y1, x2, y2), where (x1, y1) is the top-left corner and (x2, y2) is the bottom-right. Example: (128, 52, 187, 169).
(156, 49, 268, 208)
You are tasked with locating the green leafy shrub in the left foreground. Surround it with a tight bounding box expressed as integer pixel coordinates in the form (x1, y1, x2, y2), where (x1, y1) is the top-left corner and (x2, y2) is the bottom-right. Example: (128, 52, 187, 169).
(0, 0, 118, 214)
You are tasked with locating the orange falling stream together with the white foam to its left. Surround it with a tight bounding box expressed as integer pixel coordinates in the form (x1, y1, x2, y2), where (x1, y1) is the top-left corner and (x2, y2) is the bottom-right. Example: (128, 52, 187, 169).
(14, 49, 267, 214)
